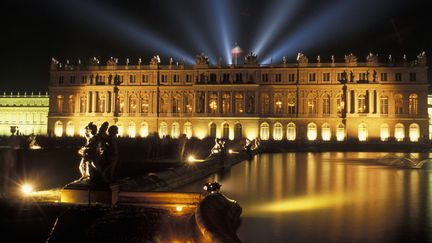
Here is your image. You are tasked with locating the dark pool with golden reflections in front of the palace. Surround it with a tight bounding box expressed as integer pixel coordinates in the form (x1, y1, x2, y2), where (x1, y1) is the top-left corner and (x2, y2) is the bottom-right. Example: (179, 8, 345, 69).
(179, 152, 432, 243)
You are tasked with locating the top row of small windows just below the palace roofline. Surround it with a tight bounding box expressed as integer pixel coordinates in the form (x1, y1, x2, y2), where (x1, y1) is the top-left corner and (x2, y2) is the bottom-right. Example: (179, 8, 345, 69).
(54, 72, 417, 84)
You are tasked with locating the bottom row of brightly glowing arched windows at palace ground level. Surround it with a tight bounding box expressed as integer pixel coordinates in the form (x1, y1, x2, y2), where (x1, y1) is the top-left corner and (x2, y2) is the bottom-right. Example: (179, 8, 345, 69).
(54, 121, 420, 142)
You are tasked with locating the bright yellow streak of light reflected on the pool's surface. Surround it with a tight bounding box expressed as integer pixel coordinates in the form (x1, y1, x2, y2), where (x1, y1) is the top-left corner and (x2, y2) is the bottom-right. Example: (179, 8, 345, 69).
(244, 194, 351, 215)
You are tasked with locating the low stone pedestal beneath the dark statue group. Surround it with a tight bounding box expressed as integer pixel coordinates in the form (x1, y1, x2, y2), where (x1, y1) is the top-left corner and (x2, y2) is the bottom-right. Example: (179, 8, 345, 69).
(60, 182, 119, 204)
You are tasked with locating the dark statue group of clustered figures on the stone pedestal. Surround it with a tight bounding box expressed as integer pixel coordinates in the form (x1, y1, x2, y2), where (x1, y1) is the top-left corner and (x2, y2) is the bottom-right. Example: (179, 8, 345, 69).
(78, 122, 118, 185)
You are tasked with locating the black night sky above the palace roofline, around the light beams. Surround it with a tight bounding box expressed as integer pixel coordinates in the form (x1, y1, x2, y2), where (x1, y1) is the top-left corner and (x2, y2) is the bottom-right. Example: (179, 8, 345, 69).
(0, 0, 432, 92)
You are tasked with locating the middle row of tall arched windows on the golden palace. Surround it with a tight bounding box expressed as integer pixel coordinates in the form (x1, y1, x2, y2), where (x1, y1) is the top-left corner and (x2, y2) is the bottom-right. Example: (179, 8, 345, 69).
(56, 92, 418, 116)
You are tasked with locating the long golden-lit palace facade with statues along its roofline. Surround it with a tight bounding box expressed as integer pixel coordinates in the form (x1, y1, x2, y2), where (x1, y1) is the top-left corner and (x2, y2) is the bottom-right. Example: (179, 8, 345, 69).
(48, 53, 429, 142)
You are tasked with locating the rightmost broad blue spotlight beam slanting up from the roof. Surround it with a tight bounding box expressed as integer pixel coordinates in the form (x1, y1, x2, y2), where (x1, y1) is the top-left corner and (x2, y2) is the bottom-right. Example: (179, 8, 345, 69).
(264, 0, 401, 63)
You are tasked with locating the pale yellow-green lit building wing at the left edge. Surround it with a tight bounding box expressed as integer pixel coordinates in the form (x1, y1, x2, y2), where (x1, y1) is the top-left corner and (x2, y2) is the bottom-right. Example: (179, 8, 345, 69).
(0, 93, 49, 136)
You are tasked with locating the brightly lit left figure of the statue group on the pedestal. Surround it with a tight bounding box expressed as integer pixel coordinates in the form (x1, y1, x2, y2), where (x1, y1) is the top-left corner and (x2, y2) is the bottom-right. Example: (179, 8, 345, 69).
(78, 122, 97, 180)
